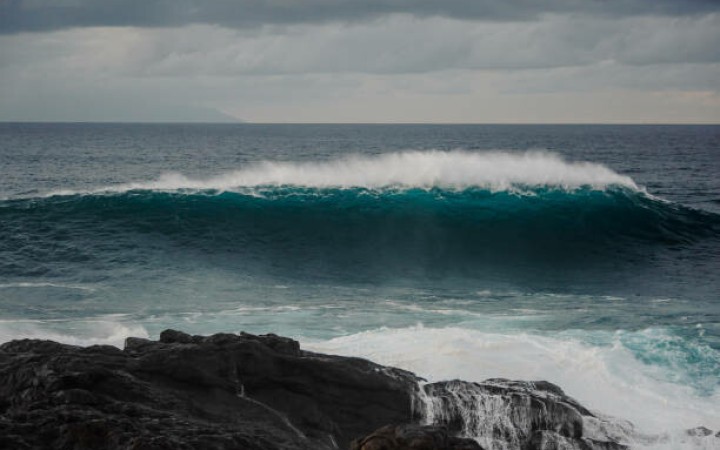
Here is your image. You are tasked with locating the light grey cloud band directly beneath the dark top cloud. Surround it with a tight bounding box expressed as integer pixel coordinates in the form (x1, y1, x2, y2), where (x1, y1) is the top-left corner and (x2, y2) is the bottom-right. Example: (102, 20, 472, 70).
(0, 14, 720, 78)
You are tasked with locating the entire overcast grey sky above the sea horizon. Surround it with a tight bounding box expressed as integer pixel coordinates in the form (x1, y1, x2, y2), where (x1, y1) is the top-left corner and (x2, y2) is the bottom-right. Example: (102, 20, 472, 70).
(0, 0, 720, 123)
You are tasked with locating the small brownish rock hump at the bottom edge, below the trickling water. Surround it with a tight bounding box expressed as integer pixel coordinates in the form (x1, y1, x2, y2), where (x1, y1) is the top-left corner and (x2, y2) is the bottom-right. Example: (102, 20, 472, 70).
(350, 425, 483, 450)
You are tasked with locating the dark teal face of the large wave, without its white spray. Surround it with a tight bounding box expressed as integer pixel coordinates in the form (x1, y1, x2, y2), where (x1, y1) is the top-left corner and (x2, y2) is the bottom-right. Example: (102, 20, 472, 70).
(0, 187, 720, 279)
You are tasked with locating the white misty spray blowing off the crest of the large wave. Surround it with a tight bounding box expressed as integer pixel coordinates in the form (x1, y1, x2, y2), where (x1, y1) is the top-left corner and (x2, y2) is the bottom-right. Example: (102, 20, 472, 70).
(47, 150, 638, 195)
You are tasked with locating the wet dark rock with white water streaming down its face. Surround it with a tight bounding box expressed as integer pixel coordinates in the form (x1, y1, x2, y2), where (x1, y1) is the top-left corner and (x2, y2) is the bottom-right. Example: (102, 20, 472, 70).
(421, 378, 627, 450)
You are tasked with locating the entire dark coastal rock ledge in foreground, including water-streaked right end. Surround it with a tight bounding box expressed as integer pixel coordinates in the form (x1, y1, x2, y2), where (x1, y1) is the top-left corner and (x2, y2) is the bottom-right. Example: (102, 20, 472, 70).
(0, 330, 626, 450)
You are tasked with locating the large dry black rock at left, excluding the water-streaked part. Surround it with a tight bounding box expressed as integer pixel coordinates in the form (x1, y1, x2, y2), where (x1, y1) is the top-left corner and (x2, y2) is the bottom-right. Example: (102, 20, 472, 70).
(0, 330, 416, 449)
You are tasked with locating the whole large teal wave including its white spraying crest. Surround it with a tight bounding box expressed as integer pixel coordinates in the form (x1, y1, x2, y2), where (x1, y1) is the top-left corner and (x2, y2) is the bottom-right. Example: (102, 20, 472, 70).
(0, 152, 720, 279)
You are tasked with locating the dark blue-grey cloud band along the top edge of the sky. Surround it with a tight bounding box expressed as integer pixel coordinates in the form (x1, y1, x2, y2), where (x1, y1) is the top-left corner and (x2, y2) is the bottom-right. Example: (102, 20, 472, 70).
(0, 0, 720, 34)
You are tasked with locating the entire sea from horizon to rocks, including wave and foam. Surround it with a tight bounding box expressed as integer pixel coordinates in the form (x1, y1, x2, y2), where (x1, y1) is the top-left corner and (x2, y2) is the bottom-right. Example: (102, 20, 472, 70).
(0, 123, 720, 449)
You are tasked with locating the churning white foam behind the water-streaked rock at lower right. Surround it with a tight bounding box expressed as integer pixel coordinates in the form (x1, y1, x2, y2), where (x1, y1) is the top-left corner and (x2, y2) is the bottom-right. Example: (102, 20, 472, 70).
(305, 326, 720, 449)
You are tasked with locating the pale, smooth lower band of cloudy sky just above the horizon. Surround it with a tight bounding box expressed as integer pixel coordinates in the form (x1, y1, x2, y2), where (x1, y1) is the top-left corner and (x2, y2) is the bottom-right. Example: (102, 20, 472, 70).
(0, 59, 720, 123)
